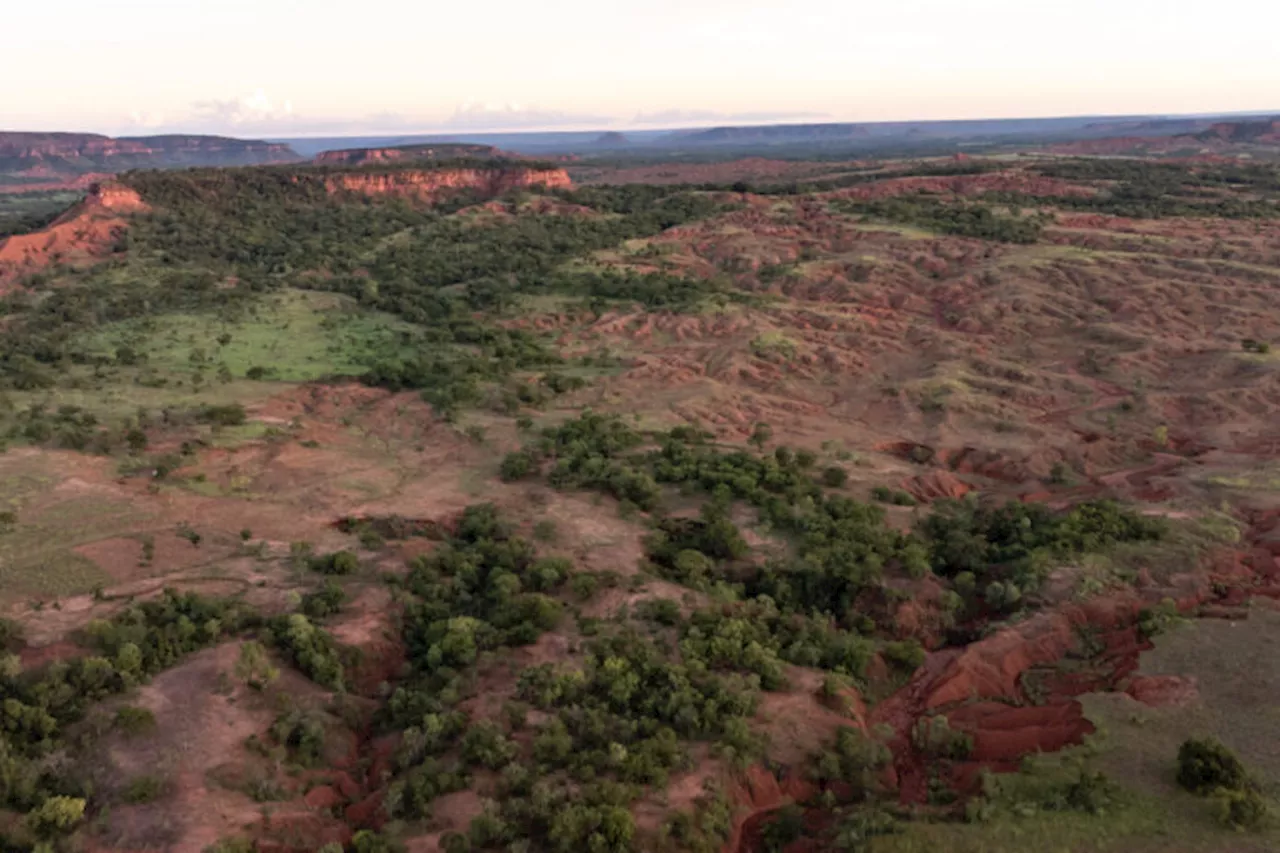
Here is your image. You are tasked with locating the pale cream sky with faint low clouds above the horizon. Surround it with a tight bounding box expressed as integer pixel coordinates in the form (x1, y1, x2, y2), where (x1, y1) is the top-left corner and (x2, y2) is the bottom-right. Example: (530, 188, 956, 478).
(0, 0, 1280, 136)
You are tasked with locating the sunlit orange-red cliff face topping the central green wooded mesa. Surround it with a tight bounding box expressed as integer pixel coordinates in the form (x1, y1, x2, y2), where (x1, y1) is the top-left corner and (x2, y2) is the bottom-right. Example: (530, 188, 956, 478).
(325, 165, 573, 201)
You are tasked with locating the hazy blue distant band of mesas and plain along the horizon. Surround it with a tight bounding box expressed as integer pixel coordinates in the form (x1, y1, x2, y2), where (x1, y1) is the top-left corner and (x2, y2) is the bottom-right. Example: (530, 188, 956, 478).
(0, 108, 1280, 192)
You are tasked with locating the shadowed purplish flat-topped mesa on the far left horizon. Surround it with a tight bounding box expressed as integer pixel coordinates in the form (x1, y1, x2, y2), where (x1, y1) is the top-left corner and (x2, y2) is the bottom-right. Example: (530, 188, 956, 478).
(0, 133, 300, 178)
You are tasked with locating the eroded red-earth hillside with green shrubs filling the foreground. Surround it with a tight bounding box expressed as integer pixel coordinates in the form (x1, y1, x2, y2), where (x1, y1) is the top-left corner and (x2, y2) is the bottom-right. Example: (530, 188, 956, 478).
(0, 158, 1280, 853)
